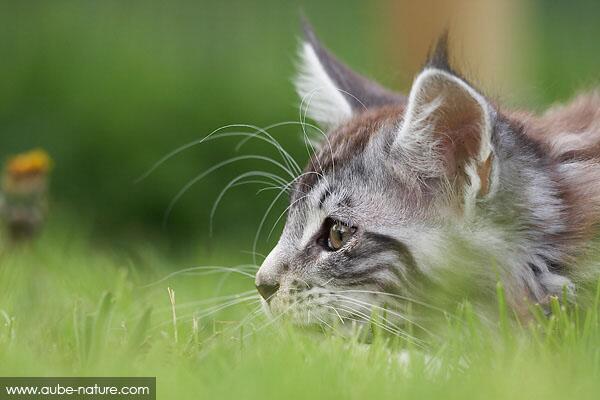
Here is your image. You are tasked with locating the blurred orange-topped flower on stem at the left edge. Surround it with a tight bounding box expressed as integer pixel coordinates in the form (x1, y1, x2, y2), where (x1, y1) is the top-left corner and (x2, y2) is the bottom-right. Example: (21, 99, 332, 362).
(0, 149, 52, 242)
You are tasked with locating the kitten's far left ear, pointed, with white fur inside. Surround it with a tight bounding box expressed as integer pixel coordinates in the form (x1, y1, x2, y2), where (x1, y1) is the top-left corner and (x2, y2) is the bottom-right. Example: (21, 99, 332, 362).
(295, 21, 406, 126)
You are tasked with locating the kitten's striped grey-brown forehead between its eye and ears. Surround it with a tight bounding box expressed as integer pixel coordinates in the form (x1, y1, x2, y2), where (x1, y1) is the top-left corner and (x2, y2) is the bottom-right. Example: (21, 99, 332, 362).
(284, 101, 428, 247)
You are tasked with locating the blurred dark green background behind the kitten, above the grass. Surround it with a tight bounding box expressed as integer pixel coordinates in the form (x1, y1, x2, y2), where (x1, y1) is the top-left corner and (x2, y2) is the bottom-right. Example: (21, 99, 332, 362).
(0, 0, 600, 255)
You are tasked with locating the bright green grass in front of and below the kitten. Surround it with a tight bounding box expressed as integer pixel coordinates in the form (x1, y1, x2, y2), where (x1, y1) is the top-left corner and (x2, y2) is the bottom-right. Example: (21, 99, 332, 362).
(0, 223, 600, 399)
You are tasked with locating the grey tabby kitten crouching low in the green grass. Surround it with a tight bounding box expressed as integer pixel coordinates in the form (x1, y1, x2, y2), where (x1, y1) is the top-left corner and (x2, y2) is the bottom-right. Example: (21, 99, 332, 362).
(256, 23, 600, 324)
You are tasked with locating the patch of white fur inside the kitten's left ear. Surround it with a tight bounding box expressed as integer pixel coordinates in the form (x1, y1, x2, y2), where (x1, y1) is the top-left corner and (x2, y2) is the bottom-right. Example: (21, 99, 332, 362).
(295, 42, 352, 126)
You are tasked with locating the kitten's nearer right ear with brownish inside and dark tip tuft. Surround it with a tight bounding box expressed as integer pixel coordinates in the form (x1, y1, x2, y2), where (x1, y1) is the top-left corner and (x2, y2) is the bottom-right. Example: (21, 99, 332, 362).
(395, 39, 494, 206)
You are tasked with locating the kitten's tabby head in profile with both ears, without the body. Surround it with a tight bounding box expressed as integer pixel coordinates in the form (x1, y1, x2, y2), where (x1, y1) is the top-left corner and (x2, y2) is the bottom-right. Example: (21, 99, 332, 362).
(256, 25, 568, 323)
